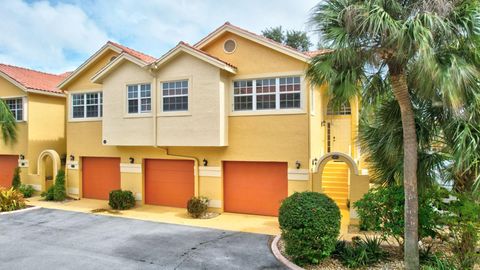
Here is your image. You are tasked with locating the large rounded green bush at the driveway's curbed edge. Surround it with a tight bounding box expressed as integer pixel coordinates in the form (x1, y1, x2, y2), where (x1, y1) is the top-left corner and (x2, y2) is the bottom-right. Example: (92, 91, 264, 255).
(278, 192, 341, 265)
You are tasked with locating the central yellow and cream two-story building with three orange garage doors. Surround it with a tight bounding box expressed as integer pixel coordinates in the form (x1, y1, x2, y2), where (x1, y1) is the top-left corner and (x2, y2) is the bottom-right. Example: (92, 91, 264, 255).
(55, 23, 368, 221)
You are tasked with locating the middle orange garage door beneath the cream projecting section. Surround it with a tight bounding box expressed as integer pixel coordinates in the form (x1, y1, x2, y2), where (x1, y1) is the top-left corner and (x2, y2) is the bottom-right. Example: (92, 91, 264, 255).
(145, 159, 194, 208)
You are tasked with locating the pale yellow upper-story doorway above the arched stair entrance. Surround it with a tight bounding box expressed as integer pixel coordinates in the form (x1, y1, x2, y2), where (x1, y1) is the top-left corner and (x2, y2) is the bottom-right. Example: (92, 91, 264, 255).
(325, 100, 352, 155)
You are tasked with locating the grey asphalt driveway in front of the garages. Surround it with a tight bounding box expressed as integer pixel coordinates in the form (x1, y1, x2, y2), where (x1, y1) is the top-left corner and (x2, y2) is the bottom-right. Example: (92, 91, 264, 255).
(0, 208, 285, 270)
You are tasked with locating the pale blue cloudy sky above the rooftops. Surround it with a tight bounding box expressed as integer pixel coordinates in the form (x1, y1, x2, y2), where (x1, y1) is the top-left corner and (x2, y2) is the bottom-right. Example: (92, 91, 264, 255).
(0, 0, 318, 73)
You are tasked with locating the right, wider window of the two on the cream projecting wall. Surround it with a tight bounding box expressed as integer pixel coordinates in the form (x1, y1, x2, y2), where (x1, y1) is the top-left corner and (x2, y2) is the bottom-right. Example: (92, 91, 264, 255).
(162, 80, 188, 112)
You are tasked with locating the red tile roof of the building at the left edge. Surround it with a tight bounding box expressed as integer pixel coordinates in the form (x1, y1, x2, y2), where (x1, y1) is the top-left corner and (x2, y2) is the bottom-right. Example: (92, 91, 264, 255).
(0, 64, 65, 94)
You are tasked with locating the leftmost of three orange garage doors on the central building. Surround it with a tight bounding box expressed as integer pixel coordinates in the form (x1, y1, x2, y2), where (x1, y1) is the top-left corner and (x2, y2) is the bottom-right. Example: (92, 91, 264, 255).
(82, 157, 120, 200)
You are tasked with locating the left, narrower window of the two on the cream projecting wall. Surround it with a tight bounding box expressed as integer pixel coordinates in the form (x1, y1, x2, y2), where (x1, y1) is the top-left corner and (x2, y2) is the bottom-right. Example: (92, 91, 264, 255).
(127, 83, 152, 114)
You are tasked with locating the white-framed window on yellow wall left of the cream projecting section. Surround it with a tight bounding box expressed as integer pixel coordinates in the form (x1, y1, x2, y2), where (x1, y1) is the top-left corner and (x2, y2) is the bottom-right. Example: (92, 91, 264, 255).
(72, 92, 103, 119)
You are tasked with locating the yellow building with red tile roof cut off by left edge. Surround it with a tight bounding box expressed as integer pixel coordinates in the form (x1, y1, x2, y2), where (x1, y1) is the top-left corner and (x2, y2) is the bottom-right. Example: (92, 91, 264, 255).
(0, 64, 67, 191)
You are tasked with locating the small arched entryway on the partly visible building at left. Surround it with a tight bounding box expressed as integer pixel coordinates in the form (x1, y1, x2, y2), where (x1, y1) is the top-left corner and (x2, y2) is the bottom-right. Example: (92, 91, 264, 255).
(37, 150, 61, 190)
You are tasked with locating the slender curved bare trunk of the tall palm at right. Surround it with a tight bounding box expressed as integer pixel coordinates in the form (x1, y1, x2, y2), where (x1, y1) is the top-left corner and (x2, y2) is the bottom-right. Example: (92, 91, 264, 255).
(390, 73, 420, 270)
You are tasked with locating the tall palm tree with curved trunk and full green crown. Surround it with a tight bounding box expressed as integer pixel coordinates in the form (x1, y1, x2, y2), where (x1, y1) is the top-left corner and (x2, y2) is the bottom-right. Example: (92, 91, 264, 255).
(307, 0, 480, 269)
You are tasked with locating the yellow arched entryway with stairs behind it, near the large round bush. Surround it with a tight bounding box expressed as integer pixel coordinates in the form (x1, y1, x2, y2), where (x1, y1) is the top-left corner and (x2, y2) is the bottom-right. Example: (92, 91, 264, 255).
(313, 152, 358, 208)
